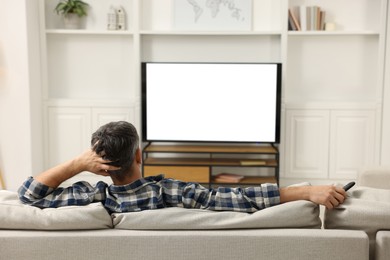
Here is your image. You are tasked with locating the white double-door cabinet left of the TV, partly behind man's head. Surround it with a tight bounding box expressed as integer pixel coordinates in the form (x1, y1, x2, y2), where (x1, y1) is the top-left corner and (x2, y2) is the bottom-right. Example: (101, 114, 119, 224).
(45, 104, 136, 167)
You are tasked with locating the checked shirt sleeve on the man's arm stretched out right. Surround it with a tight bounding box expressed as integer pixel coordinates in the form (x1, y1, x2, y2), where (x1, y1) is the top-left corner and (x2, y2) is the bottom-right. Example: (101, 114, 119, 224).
(160, 179, 280, 213)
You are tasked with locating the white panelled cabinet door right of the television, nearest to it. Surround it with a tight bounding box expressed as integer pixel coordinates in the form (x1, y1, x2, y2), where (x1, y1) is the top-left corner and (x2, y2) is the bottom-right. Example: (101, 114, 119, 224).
(285, 110, 329, 179)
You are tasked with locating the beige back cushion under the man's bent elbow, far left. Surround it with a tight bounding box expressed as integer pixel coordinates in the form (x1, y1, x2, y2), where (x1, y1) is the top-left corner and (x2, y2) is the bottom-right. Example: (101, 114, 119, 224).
(0, 190, 112, 230)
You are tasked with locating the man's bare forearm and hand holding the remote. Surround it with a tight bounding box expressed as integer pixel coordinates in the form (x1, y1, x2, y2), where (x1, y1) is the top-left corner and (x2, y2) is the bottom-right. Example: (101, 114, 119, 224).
(280, 185, 347, 209)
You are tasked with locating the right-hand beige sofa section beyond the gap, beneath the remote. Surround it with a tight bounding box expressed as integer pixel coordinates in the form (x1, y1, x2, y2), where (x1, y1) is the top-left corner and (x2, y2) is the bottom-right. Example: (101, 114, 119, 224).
(324, 166, 390, 260)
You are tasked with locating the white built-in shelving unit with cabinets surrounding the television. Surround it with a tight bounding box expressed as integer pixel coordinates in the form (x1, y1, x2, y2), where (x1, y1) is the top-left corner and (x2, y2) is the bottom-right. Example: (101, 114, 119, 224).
(39, 0, 388, 185)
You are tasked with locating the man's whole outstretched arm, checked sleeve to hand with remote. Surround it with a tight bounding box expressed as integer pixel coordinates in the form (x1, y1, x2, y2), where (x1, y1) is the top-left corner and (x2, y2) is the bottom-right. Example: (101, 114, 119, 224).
(160, 179, 346, 212)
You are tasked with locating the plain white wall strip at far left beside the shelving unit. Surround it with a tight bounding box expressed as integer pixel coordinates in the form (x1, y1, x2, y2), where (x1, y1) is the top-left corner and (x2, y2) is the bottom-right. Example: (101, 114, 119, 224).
(0, 0, 42, 190)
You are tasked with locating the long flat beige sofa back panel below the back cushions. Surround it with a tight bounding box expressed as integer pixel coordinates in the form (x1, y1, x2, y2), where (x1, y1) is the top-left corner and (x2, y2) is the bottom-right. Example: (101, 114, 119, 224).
(0, 229, 368, 260)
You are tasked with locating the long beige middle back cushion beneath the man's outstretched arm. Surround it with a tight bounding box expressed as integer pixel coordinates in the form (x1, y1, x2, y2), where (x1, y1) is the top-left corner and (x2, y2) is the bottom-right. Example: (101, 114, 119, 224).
(112, 201, 321, 230)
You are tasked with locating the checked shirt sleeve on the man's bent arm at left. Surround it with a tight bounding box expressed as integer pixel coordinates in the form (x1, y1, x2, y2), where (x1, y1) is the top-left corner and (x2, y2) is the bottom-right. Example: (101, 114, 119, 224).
(18, 177, 107, 208)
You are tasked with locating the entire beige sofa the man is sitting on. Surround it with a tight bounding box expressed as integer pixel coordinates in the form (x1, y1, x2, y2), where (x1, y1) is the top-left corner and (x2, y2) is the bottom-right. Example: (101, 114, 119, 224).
(0, 171, 390, 260)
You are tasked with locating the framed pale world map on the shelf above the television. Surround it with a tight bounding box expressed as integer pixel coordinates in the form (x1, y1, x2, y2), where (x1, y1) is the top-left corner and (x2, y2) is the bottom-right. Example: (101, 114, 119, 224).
(173, 0, 252, 31)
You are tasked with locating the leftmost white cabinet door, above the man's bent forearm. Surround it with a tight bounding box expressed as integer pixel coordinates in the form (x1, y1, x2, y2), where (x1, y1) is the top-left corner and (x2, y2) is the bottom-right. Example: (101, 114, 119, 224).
(46, 107, 91, 167)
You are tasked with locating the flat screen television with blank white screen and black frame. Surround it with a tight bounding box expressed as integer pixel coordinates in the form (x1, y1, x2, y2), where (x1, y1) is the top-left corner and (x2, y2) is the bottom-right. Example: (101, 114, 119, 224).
(141, 62, 281, 143)
